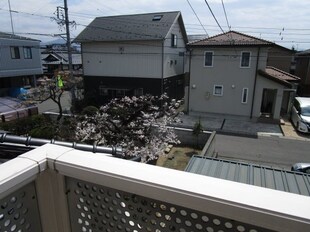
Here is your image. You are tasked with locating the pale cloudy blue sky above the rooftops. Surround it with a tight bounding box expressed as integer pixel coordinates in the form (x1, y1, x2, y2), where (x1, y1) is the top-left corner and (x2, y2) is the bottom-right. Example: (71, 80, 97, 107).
(0, 0, 310, 50)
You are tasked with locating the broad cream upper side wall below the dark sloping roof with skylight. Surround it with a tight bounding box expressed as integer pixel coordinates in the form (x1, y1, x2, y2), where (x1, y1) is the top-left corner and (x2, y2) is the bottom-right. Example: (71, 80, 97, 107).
(82, 41, 162, 78)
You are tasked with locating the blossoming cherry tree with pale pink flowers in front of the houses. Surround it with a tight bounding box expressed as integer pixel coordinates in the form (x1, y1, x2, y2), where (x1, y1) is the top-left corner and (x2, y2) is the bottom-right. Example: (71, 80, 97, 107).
(76, 95, 179, 162)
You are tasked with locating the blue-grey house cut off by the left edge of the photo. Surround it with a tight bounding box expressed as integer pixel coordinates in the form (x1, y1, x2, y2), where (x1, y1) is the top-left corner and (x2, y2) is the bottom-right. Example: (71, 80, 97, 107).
(0, 32, 42, 96)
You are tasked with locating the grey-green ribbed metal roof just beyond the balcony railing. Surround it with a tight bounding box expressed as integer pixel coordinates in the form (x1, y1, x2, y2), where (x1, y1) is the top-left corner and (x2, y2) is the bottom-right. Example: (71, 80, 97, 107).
(185, 155, 310, 196)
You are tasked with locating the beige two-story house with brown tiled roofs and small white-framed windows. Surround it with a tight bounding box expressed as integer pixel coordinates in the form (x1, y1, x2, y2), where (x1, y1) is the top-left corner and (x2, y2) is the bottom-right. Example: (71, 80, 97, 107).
(186, 31, 299, 121)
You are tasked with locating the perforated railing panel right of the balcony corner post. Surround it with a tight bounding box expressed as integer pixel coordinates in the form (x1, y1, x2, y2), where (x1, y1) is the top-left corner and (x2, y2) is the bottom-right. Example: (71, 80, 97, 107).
(67, 178, 267, 232)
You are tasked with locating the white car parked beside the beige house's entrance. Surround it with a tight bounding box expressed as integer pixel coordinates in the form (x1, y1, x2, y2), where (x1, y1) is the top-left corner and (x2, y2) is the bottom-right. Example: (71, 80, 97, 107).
(291, 97, 310, 133)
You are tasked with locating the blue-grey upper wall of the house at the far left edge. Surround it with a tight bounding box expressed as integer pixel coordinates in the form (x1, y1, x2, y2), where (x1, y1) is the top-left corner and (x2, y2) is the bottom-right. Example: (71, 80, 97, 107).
(0, 39, 42, 78)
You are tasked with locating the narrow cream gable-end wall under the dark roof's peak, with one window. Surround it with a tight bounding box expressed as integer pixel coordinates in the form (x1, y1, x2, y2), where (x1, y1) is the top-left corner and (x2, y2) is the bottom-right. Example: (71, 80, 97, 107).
(164, 21, 186, 77)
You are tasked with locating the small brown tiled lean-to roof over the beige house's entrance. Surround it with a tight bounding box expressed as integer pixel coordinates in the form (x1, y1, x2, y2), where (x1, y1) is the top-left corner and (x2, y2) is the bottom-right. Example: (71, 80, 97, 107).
(258, 66, 300, 87)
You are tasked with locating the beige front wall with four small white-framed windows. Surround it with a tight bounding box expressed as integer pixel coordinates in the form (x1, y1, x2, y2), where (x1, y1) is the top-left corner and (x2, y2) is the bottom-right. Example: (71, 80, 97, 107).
(189, 47, 267, 116)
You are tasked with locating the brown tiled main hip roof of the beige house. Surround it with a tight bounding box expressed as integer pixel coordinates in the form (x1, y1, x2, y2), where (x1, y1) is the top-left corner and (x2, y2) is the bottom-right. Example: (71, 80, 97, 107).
(188, 31, 274, 47)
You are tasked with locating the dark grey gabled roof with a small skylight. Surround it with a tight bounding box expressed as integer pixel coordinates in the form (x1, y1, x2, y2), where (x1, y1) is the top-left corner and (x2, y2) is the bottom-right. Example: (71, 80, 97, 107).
(74, 11, 187, 43)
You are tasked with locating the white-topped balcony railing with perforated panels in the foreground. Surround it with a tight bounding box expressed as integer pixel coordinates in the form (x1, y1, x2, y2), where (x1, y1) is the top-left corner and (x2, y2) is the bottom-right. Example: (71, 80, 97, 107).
(0, 144, 310, 232)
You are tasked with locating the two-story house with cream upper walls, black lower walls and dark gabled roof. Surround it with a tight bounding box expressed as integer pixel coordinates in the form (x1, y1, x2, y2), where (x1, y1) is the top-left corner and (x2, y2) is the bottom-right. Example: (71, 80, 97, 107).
(75, 11, 187, 103)
